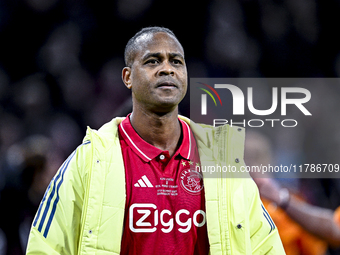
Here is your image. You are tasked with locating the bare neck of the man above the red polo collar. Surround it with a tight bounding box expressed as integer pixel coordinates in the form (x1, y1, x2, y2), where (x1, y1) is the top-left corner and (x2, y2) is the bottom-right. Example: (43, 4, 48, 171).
(130, 108, 182, 156)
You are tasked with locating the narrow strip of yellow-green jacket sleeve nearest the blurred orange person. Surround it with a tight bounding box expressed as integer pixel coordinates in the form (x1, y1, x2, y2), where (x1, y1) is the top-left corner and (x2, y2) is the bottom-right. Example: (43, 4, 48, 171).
(249, 179, 286, 255)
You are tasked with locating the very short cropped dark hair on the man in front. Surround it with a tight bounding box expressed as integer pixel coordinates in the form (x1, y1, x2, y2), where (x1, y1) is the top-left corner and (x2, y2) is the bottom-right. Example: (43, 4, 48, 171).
(124, 26, 178, 67)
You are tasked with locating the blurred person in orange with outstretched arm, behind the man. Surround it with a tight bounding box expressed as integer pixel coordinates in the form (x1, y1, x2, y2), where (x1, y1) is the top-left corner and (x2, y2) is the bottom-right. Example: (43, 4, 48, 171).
(245, 131, 340, 255)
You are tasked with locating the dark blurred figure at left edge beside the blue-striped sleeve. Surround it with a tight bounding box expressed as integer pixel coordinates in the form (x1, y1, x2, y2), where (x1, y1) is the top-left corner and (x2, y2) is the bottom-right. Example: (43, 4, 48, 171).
(0, 135, 62, 255)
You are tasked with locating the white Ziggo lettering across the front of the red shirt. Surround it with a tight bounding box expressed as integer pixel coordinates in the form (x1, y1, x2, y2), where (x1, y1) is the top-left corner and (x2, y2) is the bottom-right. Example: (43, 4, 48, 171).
(129, 203, 206, 233)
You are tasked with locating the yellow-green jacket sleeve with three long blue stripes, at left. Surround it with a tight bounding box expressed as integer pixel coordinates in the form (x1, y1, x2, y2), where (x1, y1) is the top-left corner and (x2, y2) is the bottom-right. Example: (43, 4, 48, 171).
(26, 142, 90, 255)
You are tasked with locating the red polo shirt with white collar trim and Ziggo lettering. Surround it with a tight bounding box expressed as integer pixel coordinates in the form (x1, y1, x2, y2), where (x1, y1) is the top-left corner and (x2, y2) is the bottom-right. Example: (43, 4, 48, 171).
(119, 116, 209, 255)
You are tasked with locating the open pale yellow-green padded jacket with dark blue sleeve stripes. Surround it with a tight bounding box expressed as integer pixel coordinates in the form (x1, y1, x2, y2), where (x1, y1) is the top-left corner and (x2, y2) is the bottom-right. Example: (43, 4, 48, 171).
(27, 117, 285, 255)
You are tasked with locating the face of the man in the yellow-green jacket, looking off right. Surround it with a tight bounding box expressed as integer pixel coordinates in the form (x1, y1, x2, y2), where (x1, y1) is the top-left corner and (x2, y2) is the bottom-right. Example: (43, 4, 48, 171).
(123, 32, 187, 112)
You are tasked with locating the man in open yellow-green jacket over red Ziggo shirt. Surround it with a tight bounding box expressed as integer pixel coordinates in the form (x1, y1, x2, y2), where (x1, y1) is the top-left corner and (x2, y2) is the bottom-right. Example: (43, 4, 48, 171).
(27, 27, 284, 255)
